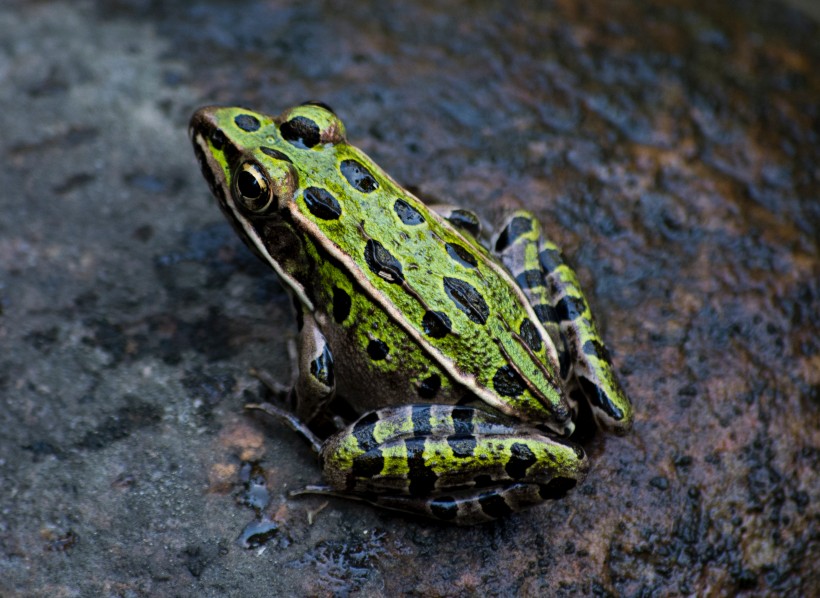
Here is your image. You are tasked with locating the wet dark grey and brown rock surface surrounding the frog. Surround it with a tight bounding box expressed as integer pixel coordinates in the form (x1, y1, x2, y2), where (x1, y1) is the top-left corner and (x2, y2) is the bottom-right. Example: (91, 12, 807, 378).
(0, 0, 820, 596)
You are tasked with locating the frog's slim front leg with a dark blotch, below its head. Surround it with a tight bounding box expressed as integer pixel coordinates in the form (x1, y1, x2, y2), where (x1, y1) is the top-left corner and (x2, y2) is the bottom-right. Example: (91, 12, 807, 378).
(293, 309, 336, 422)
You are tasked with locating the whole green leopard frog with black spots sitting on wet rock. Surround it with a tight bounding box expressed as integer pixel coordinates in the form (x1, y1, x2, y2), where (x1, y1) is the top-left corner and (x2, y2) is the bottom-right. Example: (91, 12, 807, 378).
(191, 103, 632, 524)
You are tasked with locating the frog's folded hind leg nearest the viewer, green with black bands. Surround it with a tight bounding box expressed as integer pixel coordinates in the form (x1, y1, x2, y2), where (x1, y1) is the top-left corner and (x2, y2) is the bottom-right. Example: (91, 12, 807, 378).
(304, 405, 588, 525)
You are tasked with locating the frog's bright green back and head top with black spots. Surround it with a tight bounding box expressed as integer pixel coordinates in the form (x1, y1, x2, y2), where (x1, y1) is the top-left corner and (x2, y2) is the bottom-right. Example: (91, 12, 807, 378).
(200, 105, 569, 432)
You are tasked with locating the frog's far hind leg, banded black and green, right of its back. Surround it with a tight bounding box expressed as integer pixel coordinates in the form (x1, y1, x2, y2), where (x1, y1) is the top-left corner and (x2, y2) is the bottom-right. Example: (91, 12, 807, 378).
(494, 211, 632, 434)
